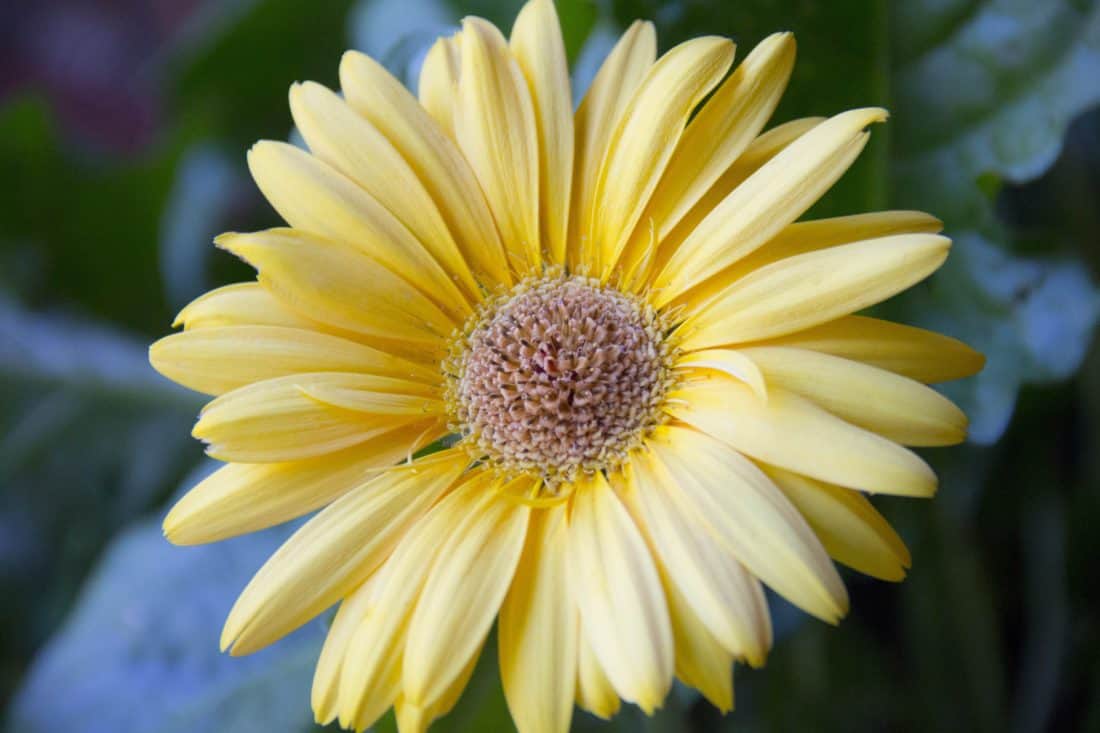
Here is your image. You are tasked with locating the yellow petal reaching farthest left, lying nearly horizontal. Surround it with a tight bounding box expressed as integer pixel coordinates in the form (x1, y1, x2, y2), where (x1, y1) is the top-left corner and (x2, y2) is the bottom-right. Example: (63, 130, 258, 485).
(149, 326, 440, 395)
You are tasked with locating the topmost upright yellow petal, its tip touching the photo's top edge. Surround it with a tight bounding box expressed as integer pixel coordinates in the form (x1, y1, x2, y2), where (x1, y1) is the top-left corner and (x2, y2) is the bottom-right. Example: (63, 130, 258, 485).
(510, 0, 573, 264)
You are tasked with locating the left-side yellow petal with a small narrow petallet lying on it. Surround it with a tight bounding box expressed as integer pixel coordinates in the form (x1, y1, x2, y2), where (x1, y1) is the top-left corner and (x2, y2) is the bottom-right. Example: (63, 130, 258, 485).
(193, 372, 433, 463)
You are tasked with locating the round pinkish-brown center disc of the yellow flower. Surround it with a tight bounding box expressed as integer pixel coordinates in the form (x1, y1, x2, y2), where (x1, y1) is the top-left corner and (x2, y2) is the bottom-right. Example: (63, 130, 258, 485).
(444, 276, 671, 491)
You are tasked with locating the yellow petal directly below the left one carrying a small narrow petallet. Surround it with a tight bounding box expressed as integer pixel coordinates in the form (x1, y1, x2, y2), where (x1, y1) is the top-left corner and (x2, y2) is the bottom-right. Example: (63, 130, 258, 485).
(164, 420, 447, 545)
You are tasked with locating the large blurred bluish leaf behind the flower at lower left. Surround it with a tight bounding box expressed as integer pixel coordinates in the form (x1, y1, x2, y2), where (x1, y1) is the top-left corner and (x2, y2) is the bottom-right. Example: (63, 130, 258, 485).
(9, 462, 323, 733)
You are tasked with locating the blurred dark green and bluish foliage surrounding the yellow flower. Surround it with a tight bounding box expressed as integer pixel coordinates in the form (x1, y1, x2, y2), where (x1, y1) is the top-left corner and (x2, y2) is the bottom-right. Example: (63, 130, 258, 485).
(0, 0, 1100, 733)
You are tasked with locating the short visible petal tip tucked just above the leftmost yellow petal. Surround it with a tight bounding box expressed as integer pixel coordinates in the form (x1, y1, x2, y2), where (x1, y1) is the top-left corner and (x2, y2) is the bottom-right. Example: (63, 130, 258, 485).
(172, 283, 317, 330)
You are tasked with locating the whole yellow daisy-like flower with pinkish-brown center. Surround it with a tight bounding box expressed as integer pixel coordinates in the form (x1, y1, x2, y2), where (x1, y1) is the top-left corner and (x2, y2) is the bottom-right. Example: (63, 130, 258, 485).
(151, 0, 982, 733)
